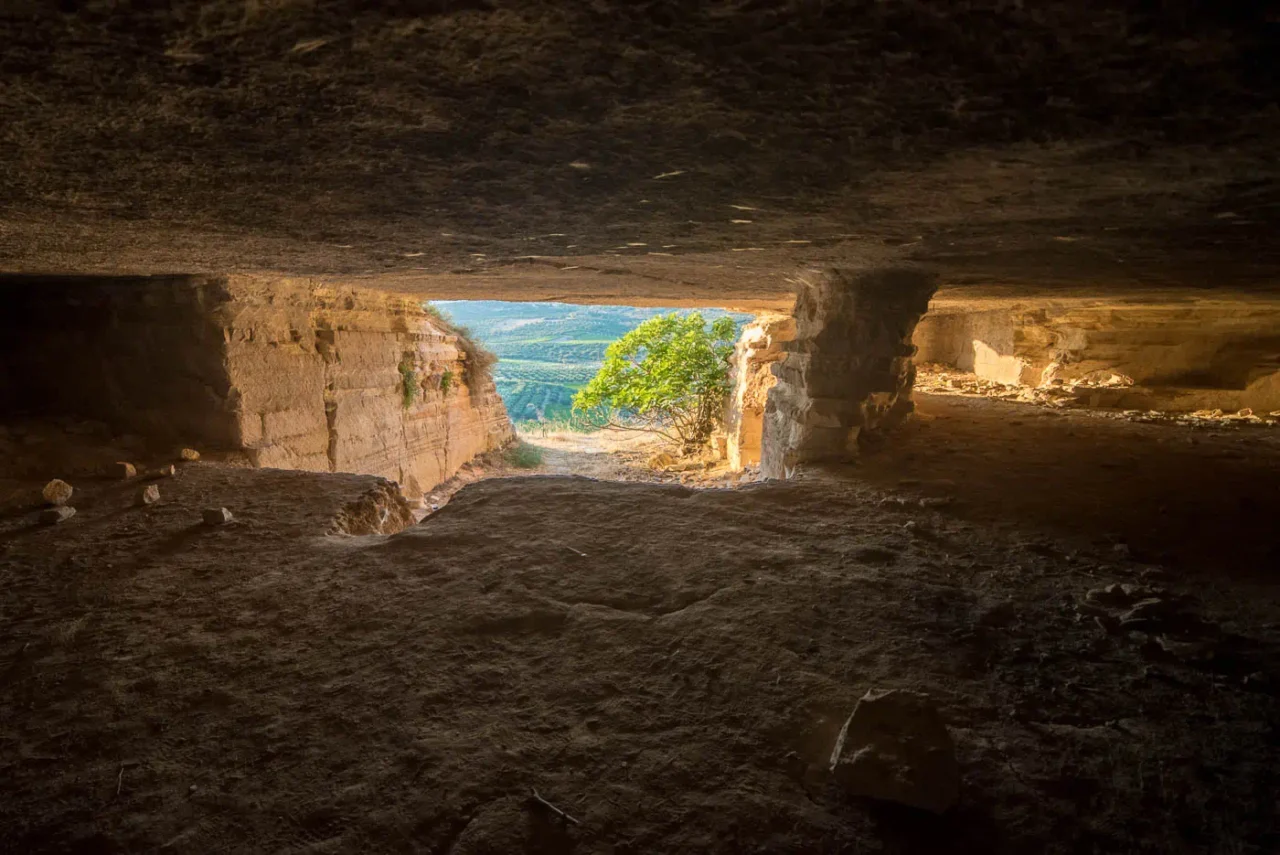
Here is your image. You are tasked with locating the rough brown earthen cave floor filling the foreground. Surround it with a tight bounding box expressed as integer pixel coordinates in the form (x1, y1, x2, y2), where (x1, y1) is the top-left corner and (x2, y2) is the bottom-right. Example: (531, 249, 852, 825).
(0, 397, 1280, 852)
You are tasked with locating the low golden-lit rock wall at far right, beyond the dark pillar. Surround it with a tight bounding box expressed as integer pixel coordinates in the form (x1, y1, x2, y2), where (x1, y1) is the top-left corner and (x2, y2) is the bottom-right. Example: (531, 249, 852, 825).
(914, 298, 1280, 411)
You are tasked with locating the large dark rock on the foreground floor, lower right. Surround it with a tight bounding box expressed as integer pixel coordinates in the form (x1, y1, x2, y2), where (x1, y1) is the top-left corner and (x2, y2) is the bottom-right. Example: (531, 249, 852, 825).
(831, 689, 960, 813)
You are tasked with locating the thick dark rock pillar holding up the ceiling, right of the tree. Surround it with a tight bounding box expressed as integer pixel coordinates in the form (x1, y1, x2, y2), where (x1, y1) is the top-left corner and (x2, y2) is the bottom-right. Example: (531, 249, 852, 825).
(760, 269, 936, 477)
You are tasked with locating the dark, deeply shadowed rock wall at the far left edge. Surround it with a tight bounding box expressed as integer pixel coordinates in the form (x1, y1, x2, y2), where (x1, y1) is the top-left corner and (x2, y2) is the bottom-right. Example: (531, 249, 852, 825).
(0, 275, 234, 448)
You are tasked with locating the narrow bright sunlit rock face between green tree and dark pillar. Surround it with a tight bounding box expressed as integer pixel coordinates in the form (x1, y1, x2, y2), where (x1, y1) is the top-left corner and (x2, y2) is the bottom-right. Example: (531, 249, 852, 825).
(724, 315, 796, 468)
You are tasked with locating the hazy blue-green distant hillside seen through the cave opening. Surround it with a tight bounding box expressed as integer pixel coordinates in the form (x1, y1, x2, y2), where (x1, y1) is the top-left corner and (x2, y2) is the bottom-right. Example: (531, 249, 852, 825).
(435, 301, 751, 422)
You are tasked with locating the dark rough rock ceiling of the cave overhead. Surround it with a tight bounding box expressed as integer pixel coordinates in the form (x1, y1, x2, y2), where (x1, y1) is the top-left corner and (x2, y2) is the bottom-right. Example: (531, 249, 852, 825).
(0, 0, 1280, 307)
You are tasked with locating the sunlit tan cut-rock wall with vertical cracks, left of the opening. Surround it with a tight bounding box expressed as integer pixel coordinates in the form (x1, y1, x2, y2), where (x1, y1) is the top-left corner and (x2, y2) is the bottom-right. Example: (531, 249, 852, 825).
(219, 278, 513, 497)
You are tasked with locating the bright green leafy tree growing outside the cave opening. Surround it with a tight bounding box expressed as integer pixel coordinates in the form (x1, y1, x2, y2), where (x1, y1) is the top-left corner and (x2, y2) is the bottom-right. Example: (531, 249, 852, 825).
(573, 312, 737, 451)
